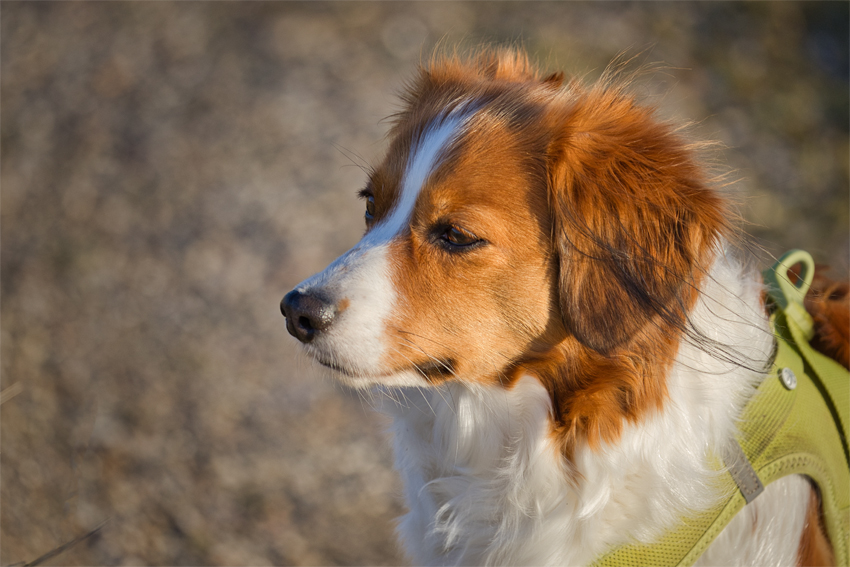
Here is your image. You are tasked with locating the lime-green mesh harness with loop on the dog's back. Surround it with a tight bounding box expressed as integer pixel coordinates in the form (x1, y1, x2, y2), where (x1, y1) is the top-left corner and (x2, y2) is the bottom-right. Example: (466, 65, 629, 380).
(593, 250, 850, 567)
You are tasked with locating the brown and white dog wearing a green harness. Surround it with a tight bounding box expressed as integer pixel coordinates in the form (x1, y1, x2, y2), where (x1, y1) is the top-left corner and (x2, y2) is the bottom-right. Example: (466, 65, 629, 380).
(281, 49, 846, 565)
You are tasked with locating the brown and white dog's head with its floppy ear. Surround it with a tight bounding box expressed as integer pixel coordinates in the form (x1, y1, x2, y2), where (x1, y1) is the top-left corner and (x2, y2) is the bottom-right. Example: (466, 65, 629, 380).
(281, 51, 723, 446)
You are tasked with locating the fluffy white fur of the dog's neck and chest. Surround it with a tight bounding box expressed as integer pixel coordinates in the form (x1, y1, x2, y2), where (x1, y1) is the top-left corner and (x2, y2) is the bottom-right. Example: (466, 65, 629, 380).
(374, 250, 773, 565)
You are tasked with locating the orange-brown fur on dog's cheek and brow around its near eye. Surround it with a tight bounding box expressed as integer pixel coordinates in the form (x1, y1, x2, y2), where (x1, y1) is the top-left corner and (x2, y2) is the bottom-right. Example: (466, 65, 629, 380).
(380, 91, 565, 383)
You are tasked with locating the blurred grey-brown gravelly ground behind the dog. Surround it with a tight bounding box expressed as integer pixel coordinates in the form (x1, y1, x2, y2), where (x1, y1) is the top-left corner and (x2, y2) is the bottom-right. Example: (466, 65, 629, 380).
(0, 2, 850, 565)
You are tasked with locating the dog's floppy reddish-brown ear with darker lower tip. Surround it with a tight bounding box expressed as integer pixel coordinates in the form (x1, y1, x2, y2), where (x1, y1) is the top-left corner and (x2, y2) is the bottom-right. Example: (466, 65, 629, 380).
(548, 87, 724, 354)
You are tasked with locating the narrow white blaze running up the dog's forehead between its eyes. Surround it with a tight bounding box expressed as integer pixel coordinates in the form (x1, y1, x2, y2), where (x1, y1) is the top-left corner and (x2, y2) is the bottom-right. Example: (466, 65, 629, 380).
(363, 109, 469, 242)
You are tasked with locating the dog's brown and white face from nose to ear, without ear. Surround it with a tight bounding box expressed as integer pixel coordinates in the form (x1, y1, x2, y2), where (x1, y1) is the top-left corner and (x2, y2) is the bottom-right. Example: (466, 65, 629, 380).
(283, 100, 564, 385)
